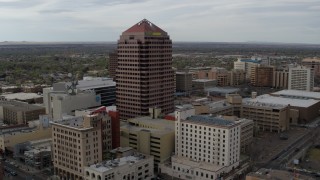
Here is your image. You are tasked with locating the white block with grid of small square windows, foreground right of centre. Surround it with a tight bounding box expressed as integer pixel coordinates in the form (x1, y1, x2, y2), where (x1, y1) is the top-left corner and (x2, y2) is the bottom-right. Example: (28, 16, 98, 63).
(166, 111, 241, 180)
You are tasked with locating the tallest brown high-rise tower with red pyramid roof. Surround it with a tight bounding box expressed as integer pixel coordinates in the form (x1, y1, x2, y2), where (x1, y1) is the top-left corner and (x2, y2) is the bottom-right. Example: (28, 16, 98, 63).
(116, 19, 174, 119)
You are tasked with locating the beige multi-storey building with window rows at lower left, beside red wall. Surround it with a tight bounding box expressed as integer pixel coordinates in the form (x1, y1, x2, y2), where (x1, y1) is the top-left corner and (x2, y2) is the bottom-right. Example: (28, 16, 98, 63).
(52, 113, 111, 179)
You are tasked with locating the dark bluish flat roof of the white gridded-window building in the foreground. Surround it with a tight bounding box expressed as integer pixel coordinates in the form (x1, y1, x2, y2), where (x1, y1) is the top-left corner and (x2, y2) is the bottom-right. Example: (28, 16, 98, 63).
(182, 115, 238, 127)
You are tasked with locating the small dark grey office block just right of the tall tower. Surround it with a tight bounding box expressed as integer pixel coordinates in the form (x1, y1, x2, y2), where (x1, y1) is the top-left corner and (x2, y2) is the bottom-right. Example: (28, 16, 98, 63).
(175, 72, 192, 93)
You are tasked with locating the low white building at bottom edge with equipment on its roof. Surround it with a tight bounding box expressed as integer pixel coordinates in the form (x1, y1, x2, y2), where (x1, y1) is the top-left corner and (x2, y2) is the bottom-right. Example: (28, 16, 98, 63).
(85, 154, 154, 180)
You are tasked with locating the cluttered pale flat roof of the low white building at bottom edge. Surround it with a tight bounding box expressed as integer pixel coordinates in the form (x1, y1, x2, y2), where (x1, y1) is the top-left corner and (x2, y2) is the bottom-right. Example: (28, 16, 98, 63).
(85, 154, 152, 173)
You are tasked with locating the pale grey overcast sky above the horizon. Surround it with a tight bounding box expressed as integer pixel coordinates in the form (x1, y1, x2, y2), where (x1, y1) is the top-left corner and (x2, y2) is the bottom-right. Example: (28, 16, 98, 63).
(0, 0, 320, 44)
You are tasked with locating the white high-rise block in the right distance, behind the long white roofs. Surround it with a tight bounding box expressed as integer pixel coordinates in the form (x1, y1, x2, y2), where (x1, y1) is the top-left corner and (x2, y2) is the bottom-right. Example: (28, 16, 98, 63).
(288, 66, 314, 91)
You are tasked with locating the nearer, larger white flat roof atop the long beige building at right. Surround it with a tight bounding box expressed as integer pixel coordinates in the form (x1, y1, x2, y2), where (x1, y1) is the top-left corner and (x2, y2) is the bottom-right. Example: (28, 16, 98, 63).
(243, 94, 320, 108)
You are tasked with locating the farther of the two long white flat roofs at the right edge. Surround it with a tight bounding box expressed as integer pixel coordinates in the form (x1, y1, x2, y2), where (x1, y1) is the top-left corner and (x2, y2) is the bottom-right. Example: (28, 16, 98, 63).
(271, 90, 320, 100)
